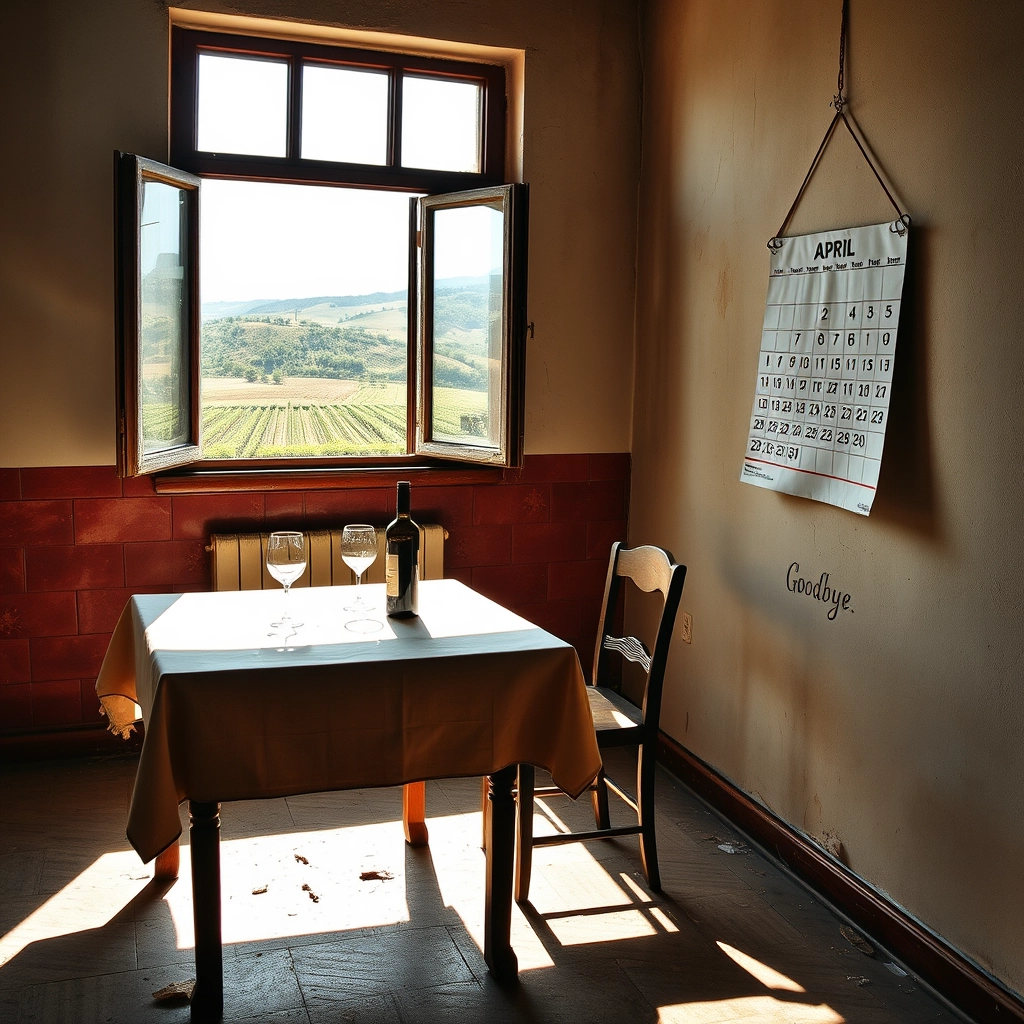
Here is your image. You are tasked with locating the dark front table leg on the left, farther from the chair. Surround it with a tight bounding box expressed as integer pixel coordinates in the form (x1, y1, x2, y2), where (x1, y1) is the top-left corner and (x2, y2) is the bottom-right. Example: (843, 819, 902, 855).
(188, 800, 224, 1024)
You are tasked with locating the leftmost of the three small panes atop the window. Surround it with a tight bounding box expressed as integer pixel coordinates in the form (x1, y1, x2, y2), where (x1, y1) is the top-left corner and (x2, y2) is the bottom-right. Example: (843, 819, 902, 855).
(197, 53, 288, 157)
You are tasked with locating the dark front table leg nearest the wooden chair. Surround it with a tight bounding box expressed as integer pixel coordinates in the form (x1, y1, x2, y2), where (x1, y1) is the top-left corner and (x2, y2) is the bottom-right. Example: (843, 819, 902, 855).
(483, 765, 519, 983)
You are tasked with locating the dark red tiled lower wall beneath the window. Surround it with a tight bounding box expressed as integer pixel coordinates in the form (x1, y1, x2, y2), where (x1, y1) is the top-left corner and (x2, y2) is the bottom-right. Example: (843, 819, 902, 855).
(0, 453, 630, 756)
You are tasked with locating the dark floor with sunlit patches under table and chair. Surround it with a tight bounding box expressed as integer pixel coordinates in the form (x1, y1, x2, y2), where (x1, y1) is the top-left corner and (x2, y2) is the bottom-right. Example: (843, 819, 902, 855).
(0, 745, 962, 1024)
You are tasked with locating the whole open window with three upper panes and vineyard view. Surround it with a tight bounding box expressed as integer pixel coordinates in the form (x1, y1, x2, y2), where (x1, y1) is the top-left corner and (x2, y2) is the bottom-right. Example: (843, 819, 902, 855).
(117, 28, 527, 475)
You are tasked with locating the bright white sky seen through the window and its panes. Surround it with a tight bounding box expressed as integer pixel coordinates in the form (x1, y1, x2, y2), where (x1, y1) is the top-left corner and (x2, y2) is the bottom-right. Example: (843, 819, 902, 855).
(191, 53, 501, 303)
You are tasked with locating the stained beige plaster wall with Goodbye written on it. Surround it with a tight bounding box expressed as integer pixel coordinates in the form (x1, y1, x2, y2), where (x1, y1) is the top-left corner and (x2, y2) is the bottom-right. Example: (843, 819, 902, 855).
(630, 0, 1024, 991)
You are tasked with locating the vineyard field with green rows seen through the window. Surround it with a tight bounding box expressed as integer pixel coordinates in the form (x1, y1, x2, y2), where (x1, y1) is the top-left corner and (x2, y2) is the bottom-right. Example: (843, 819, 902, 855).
(192, 378, 486, 459)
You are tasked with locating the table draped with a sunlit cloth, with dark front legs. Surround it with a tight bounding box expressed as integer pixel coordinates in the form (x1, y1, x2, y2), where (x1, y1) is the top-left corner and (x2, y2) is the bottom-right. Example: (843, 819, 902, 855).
(96, 580, 601, 1020)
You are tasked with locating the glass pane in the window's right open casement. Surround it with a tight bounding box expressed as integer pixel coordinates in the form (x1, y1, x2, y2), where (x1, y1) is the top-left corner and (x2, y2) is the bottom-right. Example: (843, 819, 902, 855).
(431, 201, 505, 449)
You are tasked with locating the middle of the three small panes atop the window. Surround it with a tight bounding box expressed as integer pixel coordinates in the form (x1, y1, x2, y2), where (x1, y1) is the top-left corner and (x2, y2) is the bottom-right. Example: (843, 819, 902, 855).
(302, 65, 390, 164)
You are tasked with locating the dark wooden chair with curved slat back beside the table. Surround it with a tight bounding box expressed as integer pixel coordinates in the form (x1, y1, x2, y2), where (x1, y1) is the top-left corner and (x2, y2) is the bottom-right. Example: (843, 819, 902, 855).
(515, 542, 686, 903)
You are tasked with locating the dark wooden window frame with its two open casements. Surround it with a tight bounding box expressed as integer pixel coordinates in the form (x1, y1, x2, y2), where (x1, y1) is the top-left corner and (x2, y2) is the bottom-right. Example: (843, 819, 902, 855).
(117, 26, 526, 481)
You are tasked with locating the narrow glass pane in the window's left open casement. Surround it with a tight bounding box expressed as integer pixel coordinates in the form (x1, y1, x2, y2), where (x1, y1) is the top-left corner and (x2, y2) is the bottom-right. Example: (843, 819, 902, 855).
(139, 181, 191, 452)
